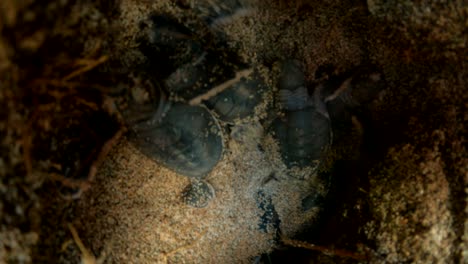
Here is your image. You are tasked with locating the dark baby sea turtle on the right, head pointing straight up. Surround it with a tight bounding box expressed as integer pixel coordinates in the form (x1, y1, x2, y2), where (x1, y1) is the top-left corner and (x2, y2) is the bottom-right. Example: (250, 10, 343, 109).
(272, 60, 332, 168)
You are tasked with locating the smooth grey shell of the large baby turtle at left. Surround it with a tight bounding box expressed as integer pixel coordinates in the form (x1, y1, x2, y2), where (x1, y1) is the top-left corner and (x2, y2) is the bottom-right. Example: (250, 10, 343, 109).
(129, 103, 223, 178)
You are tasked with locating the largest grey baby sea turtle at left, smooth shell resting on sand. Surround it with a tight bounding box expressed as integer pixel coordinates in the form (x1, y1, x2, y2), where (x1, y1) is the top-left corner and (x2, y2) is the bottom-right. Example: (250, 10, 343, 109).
(120, 76, 223, 179)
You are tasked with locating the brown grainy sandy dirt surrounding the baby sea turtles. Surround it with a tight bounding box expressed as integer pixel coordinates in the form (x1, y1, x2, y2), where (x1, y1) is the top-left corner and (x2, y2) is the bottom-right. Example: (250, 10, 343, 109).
(0, 0, 468, 263)
